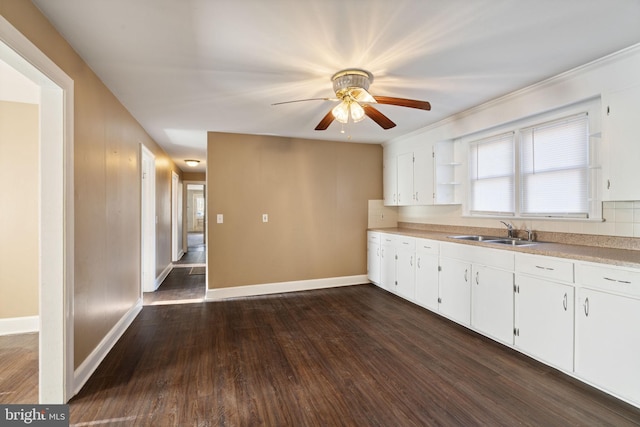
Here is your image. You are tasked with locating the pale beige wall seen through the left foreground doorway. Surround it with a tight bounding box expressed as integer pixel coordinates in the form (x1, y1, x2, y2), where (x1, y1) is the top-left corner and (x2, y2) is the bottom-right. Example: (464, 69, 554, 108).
(0, 101, 39, 319)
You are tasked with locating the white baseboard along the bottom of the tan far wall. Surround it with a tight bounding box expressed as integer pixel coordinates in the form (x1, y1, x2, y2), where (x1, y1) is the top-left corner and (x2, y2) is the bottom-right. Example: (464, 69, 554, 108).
(205, 274, 369, 301)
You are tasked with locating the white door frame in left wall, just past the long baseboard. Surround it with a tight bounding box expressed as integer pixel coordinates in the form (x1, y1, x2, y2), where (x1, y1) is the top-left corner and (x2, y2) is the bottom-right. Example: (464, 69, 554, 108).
(140, 143, 157, 297)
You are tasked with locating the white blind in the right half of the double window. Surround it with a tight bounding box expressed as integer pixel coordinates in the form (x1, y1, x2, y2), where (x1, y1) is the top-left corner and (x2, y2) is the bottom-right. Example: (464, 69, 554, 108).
(520, 114, 589, 217)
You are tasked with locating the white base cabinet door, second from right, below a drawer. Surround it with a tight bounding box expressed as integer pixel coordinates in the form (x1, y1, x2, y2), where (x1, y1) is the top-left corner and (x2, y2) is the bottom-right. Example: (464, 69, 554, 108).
(515, 274, 574, 372)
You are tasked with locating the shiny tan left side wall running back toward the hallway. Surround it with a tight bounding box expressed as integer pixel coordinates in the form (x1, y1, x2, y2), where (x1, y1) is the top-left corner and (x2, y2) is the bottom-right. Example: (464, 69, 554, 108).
(0, 0, 179, 367)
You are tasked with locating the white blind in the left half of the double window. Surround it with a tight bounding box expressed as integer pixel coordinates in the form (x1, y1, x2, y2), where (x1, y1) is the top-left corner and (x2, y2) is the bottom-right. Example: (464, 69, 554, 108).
(469, 132, 515, 215)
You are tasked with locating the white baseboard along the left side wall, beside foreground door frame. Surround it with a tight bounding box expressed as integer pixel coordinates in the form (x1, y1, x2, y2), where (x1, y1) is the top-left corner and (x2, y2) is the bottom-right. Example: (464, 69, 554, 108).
(73, 299, 142, 395)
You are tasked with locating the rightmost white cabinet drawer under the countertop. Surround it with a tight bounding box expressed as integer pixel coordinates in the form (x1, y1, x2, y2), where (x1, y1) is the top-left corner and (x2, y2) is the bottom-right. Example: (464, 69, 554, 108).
(576, 264, 640, 298)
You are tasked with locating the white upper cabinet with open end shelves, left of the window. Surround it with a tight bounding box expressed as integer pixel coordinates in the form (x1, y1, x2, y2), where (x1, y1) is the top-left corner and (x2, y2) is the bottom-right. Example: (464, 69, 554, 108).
(383, 141, 460, 206)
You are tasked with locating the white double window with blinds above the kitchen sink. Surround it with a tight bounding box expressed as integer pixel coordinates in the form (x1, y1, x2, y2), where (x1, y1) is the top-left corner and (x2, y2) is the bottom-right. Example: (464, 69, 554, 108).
(467, 107, 600, 218)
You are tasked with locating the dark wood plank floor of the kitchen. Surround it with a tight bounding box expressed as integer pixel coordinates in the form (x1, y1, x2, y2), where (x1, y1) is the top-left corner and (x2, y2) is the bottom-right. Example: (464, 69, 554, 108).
(70, 285, 640, 426)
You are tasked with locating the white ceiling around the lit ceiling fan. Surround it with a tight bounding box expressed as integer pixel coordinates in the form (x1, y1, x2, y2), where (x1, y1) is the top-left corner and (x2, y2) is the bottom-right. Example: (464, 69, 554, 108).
(33, 0, 640, 174)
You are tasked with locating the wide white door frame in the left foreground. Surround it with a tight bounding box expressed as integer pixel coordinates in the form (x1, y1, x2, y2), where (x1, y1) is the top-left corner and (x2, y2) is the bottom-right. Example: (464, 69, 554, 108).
(0, 16, 75, 404)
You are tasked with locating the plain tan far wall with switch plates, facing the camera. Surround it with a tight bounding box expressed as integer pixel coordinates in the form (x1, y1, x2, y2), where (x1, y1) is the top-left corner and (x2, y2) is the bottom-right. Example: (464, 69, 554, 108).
(207, 132, 382, 289)
